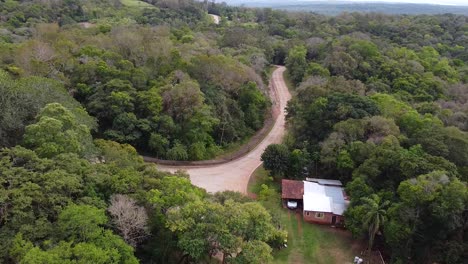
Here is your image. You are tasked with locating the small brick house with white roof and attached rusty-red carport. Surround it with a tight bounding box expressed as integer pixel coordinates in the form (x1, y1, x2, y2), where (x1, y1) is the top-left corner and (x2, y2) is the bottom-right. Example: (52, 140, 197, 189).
(281, 178, 349, 225)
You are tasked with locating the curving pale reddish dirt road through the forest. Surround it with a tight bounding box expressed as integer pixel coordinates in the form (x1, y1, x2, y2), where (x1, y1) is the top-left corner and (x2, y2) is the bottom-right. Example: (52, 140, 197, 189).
(158, 66, 291, 193)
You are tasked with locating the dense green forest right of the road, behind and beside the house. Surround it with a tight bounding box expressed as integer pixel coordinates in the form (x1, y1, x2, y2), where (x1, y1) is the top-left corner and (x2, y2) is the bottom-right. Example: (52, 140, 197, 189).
(256, 4, 468, 263)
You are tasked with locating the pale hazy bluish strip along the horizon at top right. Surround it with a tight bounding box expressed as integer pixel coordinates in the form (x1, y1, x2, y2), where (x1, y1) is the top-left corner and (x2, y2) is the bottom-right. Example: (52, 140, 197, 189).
(221, 0, 468, 15)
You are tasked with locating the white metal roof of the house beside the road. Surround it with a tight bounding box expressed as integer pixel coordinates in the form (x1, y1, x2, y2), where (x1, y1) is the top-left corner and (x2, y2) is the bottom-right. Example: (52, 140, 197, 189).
(303, 181, 348, 215)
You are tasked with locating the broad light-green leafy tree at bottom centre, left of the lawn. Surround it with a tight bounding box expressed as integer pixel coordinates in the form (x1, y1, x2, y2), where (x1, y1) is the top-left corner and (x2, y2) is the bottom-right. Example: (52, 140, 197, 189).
(166, 200, 285, 263)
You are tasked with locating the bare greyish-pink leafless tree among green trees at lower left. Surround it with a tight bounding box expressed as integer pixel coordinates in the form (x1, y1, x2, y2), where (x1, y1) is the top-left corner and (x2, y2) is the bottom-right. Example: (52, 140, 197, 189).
(107, 194, 149, 247)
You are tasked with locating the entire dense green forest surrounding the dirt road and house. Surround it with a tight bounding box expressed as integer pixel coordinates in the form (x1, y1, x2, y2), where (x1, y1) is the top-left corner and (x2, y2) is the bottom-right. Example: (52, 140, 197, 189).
(0, 0, 468, 263)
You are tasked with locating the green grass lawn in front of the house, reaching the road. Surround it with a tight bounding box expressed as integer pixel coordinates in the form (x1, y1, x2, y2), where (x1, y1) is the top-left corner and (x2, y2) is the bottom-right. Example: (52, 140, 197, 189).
(248, 167, 362, 264)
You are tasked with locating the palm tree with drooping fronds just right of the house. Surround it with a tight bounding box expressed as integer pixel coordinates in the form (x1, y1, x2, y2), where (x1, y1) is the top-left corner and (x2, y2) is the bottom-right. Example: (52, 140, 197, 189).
(361, 194, 389, 251)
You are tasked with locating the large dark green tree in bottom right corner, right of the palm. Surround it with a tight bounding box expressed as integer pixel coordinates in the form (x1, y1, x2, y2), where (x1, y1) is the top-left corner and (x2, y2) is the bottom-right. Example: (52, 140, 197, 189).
(384, 171, 468, 263)
